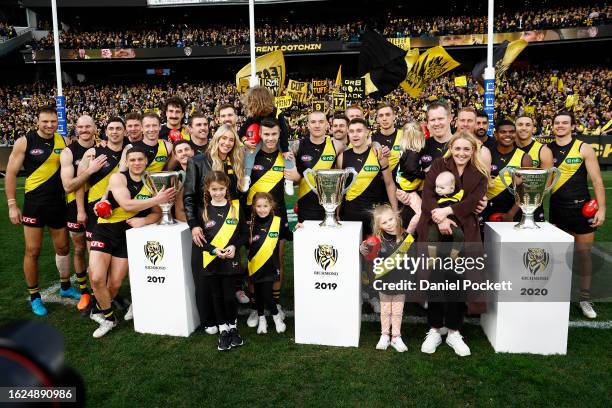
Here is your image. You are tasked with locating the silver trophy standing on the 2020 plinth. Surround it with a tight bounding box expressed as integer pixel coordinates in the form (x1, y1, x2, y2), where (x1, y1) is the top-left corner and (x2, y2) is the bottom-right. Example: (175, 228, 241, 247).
(499, 167, 561, 229)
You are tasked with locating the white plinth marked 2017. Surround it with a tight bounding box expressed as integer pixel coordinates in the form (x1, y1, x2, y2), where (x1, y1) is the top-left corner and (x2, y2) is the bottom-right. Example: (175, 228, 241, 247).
(126, 223, 200, 337)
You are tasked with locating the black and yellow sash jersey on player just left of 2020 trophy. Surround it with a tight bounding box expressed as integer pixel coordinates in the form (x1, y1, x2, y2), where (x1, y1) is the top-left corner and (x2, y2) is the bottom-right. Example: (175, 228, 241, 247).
(487, 147, 525, 207)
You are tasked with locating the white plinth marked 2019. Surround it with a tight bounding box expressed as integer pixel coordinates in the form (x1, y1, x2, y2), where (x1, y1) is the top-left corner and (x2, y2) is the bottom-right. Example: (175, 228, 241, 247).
(293, 221, 361, 347)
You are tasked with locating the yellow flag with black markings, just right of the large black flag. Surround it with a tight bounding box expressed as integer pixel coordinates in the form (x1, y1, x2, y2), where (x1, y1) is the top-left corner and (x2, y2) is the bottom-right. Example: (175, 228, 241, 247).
(400, 45, 460, 98)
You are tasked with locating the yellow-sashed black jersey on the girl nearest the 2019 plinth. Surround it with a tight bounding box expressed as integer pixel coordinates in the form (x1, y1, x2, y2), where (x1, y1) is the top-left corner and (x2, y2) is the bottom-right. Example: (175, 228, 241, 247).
(248, 215, 283, 282)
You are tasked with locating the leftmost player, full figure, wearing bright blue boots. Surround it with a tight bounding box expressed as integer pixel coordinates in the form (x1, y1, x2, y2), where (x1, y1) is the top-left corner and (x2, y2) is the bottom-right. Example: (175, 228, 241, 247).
(5, 106, 74, 316)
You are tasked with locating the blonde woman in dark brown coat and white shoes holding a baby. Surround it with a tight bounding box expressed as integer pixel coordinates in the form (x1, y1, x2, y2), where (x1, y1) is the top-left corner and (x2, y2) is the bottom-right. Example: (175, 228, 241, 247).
(417, 131, 489, 356)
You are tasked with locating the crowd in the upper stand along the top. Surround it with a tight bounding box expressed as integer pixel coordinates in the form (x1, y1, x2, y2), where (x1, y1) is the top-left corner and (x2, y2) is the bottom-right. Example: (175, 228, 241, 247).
(35, 5, 612, 49)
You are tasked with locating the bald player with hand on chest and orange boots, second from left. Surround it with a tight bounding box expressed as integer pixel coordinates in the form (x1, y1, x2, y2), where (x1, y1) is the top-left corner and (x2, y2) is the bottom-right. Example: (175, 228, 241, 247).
(60, 115, 106, 310)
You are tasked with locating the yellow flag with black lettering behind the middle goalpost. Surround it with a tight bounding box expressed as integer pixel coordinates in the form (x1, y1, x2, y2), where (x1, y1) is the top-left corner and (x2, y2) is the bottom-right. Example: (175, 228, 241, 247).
(236, 50, 286, 95)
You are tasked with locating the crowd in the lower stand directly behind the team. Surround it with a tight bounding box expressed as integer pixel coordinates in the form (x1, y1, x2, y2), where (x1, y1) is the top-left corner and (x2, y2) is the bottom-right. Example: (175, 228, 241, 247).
(0, 67, 612, 145)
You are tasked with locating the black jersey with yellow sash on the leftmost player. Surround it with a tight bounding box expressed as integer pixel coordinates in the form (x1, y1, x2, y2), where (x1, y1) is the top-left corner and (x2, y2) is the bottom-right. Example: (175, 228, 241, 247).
(23, 131, 66, 204)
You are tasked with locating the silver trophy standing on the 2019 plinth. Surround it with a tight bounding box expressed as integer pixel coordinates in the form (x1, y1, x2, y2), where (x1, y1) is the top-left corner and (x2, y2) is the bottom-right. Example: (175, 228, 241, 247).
(304, 168, 357, 227)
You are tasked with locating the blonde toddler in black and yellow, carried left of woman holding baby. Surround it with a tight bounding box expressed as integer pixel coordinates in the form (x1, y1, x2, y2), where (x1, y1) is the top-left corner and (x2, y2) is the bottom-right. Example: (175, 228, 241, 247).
(394, 122, 425, 233)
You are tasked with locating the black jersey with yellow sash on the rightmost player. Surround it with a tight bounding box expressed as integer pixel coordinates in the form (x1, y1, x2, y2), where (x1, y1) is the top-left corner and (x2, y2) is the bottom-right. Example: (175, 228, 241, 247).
(548, 139, 590, 206)
